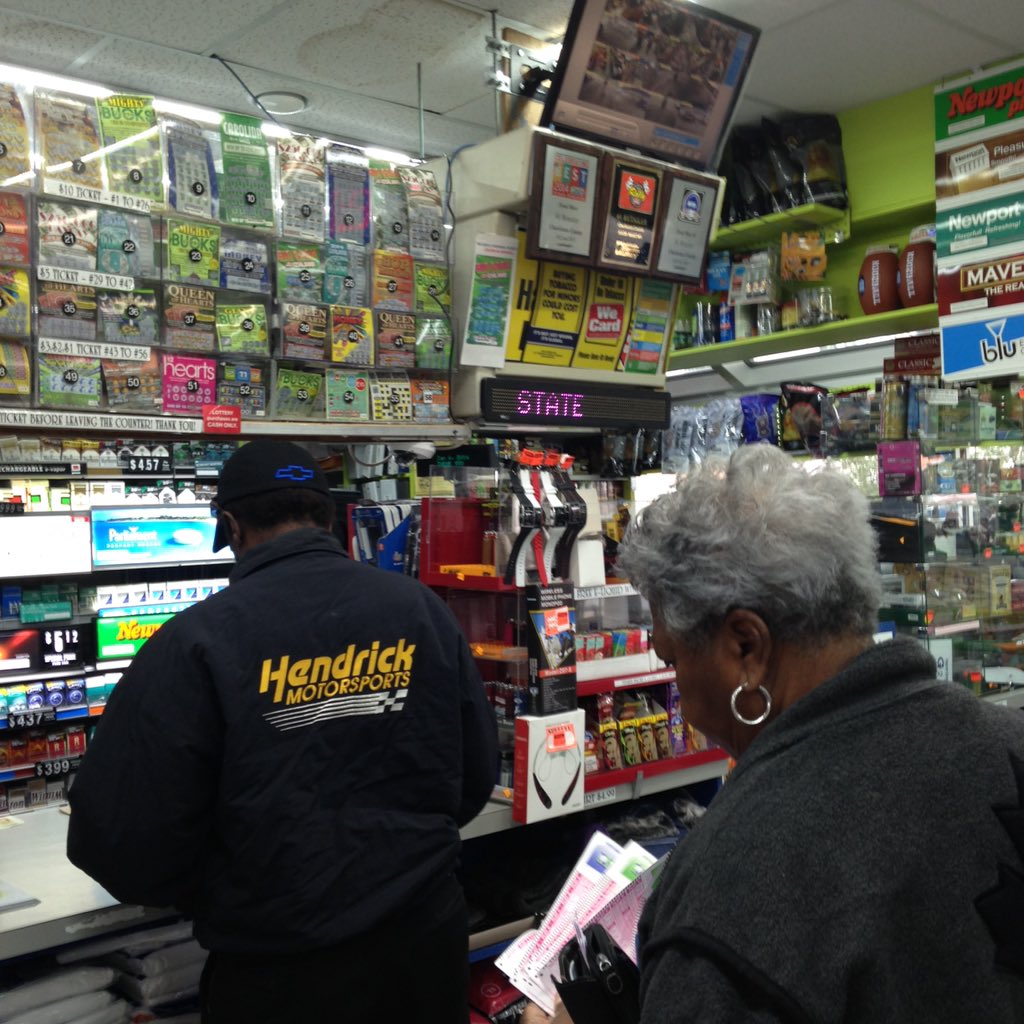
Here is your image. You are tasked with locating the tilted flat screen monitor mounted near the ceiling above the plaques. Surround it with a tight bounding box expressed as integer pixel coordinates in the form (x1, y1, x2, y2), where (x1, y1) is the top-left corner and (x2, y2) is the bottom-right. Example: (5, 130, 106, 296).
(542, 0, 761, 170)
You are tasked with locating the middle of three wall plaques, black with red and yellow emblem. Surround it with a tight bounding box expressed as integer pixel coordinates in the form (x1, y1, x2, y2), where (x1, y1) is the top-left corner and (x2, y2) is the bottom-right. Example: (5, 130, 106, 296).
(596, 154, 664, 272)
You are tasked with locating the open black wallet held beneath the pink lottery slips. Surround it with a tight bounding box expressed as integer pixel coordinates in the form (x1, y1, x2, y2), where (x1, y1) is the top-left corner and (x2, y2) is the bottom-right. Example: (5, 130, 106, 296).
(555, 925, 640, 1024)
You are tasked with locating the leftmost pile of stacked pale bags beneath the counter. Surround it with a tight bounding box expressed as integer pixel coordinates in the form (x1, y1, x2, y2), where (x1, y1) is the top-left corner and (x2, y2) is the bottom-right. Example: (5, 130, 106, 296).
(0, 967, 131, 1024)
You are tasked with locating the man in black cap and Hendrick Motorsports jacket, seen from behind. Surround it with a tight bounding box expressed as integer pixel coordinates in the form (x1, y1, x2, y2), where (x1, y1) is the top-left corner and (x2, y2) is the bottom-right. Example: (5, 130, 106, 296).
(68, 440, 497, 1024)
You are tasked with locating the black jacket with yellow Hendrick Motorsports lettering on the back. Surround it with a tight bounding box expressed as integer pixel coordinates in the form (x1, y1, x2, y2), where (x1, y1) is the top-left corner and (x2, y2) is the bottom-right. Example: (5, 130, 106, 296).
(68, 529, 497, 952)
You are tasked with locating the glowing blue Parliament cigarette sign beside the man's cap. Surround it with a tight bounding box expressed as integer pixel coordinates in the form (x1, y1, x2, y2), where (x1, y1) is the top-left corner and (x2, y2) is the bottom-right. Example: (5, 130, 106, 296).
(92, 505, 231, 569)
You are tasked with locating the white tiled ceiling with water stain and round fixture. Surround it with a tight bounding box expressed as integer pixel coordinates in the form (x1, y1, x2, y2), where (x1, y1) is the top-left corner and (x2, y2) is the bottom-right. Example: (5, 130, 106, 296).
(0, 0, 1024, 156)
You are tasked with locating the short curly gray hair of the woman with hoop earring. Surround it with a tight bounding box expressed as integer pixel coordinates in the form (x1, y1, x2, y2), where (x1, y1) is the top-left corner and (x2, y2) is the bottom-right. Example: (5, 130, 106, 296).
(617, 444, 882, 647)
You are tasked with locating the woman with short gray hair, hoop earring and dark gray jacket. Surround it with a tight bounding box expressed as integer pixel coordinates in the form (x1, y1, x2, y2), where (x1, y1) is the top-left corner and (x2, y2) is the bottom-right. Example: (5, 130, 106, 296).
(523, 445, 1024, 1024)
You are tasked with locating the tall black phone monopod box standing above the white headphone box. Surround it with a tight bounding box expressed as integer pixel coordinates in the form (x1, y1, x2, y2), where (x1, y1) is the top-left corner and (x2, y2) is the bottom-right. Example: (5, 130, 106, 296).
(526, 583, 577, 715)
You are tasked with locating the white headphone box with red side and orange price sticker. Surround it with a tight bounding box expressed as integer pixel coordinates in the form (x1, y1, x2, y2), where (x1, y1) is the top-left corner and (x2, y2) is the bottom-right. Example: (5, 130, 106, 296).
(512, 708, 586, 824)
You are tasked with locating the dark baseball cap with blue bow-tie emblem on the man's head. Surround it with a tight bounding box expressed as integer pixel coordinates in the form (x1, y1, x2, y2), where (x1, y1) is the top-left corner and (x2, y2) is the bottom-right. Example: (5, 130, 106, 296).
(213, 438, 331, 551)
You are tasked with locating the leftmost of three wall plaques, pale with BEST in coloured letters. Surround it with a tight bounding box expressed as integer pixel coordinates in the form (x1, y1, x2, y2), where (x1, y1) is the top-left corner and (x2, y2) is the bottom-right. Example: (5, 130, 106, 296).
(526, 132, 601, 264)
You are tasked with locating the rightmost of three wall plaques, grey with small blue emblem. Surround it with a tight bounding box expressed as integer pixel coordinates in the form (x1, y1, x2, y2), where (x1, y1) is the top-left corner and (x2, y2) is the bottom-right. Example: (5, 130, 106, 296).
(653, 169, 724, 285)
